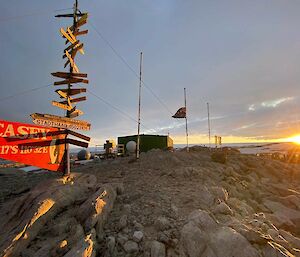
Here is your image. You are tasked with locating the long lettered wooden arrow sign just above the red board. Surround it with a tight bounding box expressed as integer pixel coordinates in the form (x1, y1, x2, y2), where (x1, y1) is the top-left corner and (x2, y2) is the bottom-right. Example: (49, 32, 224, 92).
(30, 113, 91, 130)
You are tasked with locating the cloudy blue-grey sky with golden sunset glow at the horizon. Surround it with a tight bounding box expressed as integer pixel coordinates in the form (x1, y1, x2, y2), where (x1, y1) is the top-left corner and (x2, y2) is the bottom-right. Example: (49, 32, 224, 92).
(0, 0, 300, 145)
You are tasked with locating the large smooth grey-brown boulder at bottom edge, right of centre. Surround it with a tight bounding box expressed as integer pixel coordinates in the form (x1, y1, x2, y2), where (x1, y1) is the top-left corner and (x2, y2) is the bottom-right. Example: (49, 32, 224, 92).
(181, 210, 259, 257)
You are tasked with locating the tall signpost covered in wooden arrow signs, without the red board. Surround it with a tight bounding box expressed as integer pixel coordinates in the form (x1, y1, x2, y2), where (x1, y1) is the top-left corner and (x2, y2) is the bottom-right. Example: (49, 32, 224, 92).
(31, 0, 91, 176)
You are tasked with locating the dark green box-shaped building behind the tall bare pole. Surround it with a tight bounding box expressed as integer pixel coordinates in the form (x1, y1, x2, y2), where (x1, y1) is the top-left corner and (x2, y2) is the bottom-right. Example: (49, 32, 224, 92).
(118, 135, 173, 152)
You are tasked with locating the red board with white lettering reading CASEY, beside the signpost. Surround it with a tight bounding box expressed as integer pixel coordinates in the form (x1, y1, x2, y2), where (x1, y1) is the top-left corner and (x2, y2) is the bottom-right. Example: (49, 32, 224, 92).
(0, 120, 66, 171)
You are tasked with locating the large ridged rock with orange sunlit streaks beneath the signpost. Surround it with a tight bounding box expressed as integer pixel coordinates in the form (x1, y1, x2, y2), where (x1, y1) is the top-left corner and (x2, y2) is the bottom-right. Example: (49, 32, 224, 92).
(0, 174, 116, 256)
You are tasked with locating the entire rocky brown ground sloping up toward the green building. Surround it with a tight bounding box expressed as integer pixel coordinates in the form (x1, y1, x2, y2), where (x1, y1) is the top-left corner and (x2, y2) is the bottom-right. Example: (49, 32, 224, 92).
(0, 147, 300, 257)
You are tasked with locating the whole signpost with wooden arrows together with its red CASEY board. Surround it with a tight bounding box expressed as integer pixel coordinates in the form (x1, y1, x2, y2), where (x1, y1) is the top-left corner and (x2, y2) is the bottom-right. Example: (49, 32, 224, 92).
(0, 0, 91, 176)
